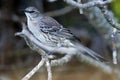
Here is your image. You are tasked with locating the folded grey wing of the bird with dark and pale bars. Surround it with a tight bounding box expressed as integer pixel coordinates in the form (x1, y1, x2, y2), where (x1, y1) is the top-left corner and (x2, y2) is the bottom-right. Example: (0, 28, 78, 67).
(40, 16, 74, 39)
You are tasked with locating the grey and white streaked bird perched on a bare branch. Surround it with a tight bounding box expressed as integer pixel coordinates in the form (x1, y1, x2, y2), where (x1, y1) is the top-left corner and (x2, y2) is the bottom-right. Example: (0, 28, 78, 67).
(24, 6, 103, 60)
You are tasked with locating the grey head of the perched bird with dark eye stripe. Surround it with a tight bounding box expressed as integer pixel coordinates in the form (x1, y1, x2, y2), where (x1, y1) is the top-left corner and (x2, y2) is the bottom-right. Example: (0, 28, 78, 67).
(24, 7, 40, 19)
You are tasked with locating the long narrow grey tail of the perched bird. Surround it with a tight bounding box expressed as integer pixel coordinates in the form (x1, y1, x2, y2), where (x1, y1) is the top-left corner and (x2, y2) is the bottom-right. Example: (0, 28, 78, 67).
(75, 43, 106, 61)
